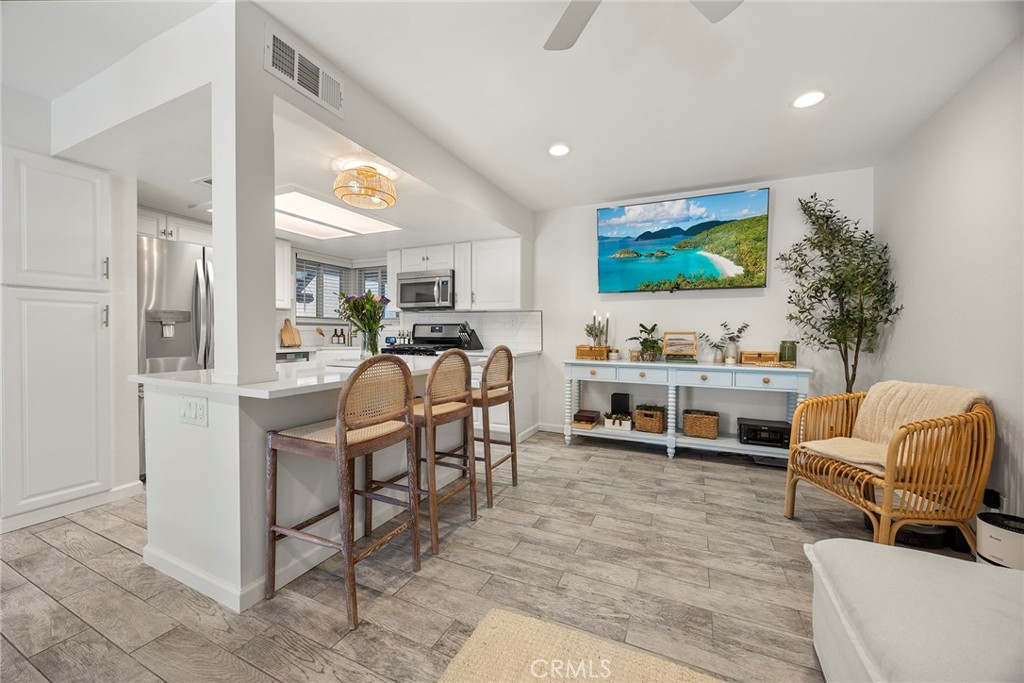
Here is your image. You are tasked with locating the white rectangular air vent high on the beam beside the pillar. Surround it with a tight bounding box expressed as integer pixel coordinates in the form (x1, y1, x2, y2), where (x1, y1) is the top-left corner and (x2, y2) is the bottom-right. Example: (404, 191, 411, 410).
(263, 26, 345, 118)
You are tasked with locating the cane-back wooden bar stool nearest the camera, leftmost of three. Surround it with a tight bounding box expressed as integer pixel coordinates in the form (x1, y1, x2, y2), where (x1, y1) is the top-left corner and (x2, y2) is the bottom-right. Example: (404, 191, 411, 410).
(266, 355, 420, 630)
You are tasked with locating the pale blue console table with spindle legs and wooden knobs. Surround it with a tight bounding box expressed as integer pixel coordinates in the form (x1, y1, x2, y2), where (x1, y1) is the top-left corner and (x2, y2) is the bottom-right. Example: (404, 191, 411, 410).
(563, 360, 814, 458)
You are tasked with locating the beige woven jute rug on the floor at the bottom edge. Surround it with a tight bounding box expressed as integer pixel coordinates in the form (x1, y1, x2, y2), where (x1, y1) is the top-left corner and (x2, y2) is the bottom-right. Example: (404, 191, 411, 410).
(439, 609, 718, 683)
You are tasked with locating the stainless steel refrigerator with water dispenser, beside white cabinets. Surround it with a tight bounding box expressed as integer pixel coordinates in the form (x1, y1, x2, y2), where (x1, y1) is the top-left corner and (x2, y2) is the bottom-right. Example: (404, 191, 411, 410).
(138, 237, 213, 481)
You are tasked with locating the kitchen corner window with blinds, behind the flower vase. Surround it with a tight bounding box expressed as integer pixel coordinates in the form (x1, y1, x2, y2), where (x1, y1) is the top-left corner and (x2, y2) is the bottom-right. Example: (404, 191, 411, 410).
(295, 257, 398, 324)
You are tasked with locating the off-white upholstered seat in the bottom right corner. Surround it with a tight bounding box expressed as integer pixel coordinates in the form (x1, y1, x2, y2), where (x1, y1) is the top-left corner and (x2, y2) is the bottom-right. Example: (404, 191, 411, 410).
(804, 539, 1024, 683)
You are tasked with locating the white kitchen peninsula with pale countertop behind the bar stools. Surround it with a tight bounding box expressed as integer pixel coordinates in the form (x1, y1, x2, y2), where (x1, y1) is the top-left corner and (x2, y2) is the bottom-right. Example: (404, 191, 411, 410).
(129, 350, 540, 611)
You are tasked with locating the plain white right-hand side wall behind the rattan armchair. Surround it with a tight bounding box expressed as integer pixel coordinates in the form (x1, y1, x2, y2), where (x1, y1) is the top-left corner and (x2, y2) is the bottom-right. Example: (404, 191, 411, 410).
(874, 38, 1024, 515)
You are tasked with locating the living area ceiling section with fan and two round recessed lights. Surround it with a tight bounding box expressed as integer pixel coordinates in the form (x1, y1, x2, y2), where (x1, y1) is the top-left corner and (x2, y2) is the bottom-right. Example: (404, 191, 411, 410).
(253, 1, 1022, 209)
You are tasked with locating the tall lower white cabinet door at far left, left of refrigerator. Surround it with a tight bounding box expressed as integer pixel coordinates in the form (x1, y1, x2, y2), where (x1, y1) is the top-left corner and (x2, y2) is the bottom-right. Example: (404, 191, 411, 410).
(0, 287, 112, 518)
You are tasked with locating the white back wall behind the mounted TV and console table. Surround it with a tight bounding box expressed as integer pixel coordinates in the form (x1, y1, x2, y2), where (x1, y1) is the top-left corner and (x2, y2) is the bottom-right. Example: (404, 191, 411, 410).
(535, 169, 873, 431)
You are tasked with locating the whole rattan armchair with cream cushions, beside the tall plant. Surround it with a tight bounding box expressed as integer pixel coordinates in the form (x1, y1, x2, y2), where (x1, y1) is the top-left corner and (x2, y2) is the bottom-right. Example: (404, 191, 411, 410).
(784, 382, 995, 550)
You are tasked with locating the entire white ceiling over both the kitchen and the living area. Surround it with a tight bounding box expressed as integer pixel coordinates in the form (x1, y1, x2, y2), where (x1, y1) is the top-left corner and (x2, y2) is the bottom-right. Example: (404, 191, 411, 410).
(0, 0, 1024, 256)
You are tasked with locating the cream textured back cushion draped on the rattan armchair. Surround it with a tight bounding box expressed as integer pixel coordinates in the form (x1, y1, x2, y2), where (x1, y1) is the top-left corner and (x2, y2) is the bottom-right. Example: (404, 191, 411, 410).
(851, 380, 987, 443)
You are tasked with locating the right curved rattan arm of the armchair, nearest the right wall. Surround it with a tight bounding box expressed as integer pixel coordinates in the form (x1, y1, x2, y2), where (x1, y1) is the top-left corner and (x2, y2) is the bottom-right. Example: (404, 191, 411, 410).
(884, 403, 995, 518)
